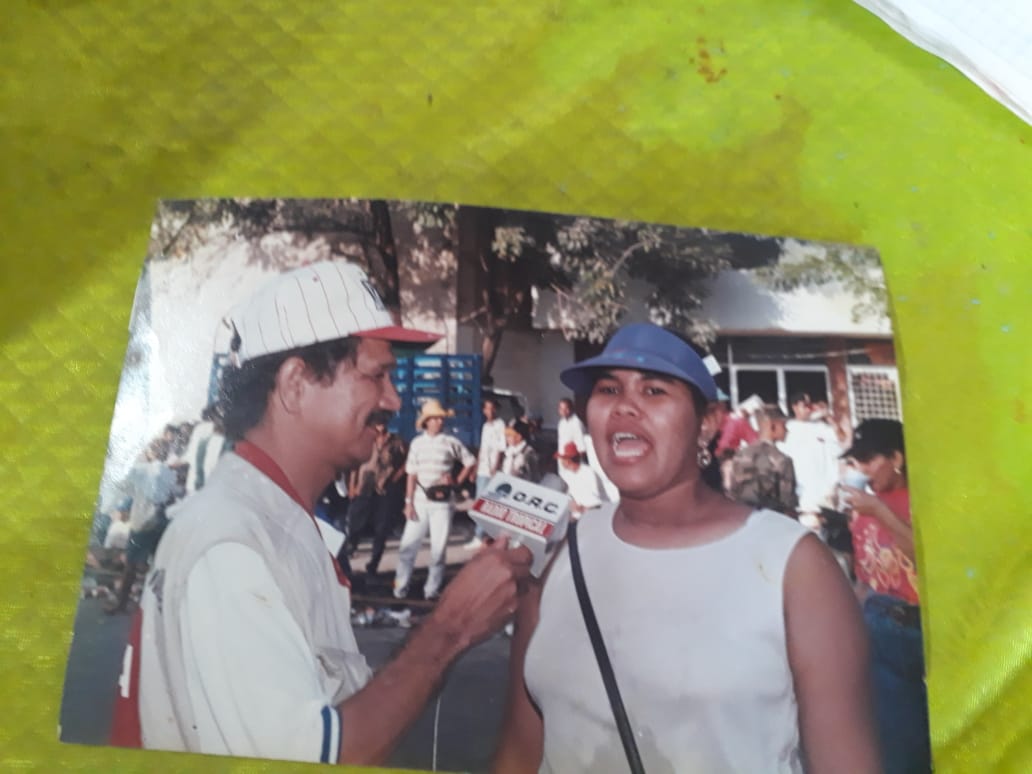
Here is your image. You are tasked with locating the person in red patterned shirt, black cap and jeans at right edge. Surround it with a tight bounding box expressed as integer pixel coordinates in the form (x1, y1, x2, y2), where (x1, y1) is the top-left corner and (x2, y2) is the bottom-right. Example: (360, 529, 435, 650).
(842, 419, 932, 774)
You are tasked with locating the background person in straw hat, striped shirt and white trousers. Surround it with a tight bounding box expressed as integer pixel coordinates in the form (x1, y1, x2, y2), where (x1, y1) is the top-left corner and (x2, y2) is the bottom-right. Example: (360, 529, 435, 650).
(394, 398, 477, 600)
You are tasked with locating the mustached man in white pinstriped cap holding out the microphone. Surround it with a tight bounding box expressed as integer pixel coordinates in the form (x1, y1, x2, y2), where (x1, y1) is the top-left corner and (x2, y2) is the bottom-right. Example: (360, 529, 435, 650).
(111, 261, 530, 764)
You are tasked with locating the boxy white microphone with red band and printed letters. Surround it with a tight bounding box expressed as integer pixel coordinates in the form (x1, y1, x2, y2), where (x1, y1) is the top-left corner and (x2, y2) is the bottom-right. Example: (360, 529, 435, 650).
(469, 473, 571, 578)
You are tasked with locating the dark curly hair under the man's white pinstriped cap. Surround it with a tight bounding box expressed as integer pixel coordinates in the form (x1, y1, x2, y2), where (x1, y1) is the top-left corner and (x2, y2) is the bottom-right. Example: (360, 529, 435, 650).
(219, 336, 359, 441)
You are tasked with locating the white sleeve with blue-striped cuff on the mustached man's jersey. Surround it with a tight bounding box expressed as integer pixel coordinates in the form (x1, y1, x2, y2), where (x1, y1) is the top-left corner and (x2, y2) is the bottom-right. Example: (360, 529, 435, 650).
(180, 543, 341, 763)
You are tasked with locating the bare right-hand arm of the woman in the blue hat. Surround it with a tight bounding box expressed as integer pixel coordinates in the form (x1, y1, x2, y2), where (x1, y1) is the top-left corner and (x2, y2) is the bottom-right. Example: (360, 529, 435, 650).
(784, 536, 881, 774)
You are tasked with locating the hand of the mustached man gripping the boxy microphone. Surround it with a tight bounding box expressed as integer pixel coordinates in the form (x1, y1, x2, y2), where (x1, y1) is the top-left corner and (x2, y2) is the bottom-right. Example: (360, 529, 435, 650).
(431, 538, 534, 649)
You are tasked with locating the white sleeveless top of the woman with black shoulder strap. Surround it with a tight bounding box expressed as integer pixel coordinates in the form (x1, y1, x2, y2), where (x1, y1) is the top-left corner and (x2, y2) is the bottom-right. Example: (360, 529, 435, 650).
(524, 505, 809, 774)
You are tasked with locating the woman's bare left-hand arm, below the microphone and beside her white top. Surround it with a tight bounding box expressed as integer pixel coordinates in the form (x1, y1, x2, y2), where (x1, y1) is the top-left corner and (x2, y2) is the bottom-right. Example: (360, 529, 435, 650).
(491, 580, 545, 774)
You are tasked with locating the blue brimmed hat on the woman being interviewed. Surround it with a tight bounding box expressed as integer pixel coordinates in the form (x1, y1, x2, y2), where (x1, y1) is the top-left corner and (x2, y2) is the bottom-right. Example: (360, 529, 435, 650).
(559, 323, 717, 400)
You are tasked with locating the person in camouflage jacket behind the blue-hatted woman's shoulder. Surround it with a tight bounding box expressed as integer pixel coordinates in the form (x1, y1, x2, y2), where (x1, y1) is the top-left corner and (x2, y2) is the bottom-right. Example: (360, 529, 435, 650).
(728, 406, 799, 516)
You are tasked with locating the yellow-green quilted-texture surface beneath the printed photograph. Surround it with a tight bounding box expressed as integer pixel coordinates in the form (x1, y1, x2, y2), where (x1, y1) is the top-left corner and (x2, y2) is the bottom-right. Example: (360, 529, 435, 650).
(0, 0, 1032, 773)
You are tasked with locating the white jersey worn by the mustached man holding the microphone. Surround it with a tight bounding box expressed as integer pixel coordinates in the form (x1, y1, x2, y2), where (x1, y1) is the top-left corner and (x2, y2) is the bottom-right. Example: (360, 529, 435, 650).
(137, 454, 372, 763)
